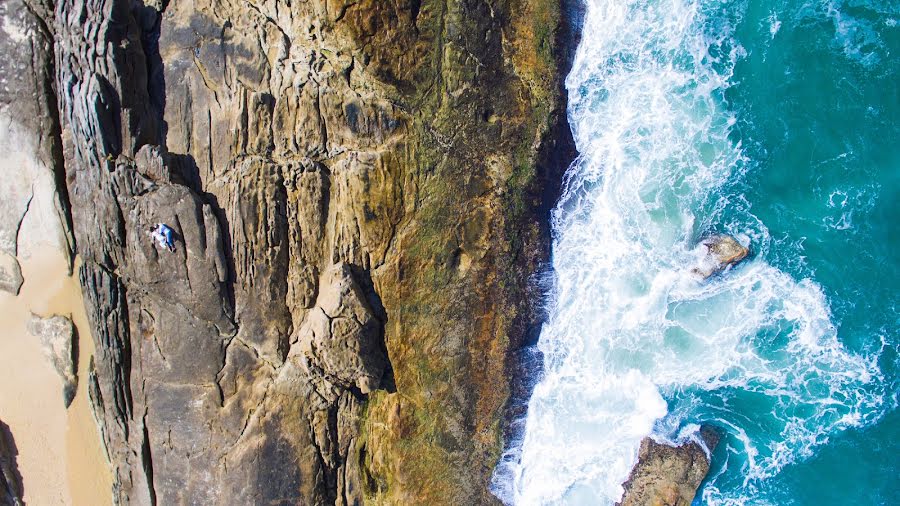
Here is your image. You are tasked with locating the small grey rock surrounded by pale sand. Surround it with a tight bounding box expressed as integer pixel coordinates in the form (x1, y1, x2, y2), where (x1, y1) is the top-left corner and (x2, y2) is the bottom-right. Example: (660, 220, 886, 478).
(27, 313, 78, 407)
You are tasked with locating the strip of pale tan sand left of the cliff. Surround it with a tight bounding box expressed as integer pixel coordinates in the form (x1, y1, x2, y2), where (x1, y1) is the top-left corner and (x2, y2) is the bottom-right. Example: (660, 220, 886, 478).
(0, 253, 112, 506)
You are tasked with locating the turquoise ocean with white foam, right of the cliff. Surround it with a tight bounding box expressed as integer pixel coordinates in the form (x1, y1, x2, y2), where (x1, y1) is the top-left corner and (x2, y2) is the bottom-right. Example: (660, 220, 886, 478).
(493, 0, 900, 505)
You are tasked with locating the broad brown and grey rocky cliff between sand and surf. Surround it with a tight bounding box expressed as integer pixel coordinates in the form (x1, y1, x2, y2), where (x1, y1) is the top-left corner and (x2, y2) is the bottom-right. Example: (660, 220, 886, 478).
(3, 0, 567, 504)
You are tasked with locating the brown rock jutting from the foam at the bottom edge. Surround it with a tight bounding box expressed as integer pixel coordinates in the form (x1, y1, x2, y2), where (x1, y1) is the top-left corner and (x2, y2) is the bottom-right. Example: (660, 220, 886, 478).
(619, 427, 719, 506)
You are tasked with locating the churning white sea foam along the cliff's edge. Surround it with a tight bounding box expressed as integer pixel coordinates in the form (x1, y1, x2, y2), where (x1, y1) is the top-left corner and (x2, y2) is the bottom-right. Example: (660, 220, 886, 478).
(493, 0, 880, 505)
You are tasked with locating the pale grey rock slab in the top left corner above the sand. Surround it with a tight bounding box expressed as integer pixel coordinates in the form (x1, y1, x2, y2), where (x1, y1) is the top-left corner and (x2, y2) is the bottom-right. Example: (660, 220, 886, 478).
(0, 0, 73, 294)
